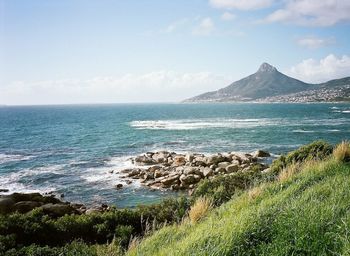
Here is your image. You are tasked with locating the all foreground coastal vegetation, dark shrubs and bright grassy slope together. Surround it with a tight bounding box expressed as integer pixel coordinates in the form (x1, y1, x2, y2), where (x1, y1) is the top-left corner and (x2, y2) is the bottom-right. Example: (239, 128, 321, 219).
(0, 141, 350, 256)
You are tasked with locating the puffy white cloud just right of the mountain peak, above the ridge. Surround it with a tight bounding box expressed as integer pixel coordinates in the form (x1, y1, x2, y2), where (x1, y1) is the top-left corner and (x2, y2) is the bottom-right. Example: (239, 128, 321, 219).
(286, 54, 350, 83)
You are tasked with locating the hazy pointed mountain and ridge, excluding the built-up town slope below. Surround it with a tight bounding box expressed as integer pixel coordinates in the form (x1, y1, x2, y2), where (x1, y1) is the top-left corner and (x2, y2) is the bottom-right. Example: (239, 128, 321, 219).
(184, 63, 350, 102)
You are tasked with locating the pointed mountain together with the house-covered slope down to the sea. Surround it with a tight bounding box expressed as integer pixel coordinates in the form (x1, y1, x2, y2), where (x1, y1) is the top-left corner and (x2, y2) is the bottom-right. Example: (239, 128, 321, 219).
(184, 63, 350, 103)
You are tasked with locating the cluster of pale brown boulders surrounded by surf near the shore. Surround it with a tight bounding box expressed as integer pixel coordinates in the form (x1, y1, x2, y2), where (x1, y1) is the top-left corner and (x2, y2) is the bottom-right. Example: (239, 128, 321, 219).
(119, 150, 270, 190)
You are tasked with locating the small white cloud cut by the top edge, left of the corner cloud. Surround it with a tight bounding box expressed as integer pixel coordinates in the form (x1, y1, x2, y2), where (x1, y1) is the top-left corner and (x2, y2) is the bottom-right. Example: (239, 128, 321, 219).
(209, 0, 273, 10)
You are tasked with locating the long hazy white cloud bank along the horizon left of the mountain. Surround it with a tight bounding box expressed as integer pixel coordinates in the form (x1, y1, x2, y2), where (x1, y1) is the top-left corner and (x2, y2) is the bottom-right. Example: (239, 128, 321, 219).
(0, 71, 232, 104)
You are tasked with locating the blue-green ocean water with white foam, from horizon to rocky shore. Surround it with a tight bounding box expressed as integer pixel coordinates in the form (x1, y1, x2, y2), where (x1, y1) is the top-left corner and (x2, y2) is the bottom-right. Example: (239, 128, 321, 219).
(0, 103, 350, 207)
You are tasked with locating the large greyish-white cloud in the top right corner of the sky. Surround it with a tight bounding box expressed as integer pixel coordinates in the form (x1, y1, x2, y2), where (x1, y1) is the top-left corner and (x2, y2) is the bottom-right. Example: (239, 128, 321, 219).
(265, 0, 350, 26)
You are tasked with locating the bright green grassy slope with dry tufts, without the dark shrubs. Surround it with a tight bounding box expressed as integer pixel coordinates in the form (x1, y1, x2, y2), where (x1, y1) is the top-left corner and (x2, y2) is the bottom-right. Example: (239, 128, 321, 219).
(128, 159, 350, 255)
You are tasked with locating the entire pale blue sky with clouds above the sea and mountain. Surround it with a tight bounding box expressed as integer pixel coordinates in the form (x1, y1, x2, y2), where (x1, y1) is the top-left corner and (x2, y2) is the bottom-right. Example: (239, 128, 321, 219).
(0, 0, 350, 105)
